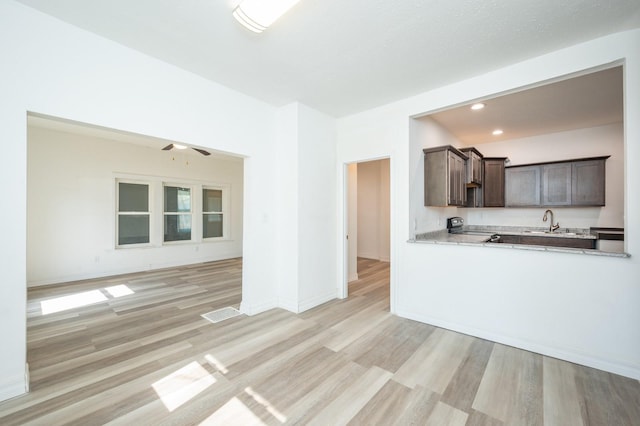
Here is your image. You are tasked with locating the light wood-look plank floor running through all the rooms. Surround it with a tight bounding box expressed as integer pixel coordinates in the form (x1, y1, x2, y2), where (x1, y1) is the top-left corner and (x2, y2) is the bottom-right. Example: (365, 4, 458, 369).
(0, 259, 640, 426)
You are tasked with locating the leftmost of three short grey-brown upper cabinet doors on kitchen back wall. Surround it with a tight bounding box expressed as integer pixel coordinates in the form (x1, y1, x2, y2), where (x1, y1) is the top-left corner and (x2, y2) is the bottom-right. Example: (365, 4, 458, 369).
(505, 166, 540, 207)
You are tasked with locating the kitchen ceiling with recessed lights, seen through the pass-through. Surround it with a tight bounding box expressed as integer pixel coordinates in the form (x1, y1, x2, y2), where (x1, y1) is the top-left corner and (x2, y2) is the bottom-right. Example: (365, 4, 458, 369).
(427, 66, 624, 146)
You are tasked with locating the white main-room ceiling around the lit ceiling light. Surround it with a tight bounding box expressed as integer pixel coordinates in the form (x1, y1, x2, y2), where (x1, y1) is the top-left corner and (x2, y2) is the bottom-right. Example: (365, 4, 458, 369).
(13, 0, 640, 117)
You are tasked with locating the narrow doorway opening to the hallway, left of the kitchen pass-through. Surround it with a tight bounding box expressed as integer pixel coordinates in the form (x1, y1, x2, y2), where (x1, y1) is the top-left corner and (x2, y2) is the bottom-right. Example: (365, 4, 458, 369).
(344, 158, 391, 308)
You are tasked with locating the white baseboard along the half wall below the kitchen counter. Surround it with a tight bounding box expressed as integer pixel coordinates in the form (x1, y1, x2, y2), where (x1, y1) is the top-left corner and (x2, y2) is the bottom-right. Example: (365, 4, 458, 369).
(396, 307, 640, 380)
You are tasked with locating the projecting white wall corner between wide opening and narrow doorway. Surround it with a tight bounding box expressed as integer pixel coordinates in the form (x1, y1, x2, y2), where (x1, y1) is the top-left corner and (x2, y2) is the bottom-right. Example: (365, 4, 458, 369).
(277, 103, 338, 312)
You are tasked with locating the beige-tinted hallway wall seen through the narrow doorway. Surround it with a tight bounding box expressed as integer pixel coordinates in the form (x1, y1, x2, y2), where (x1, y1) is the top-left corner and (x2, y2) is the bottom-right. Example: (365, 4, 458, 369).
(357, 159, 390, 262)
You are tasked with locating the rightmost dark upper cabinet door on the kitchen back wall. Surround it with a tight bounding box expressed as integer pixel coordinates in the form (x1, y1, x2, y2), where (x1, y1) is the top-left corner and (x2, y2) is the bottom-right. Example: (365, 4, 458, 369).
(571, 160, 605, 206)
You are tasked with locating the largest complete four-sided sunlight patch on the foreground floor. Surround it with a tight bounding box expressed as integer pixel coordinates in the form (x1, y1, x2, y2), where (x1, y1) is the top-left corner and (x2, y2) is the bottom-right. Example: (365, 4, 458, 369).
(152, 361, 217, 412)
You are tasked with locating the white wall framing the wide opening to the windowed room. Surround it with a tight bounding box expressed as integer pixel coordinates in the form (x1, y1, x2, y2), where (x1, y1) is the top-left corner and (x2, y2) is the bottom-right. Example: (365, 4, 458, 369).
(0, 0, 280, 400)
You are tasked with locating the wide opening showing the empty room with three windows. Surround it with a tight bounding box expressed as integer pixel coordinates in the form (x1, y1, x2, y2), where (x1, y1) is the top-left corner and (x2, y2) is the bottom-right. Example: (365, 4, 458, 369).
(26, 113, 246, 389)
